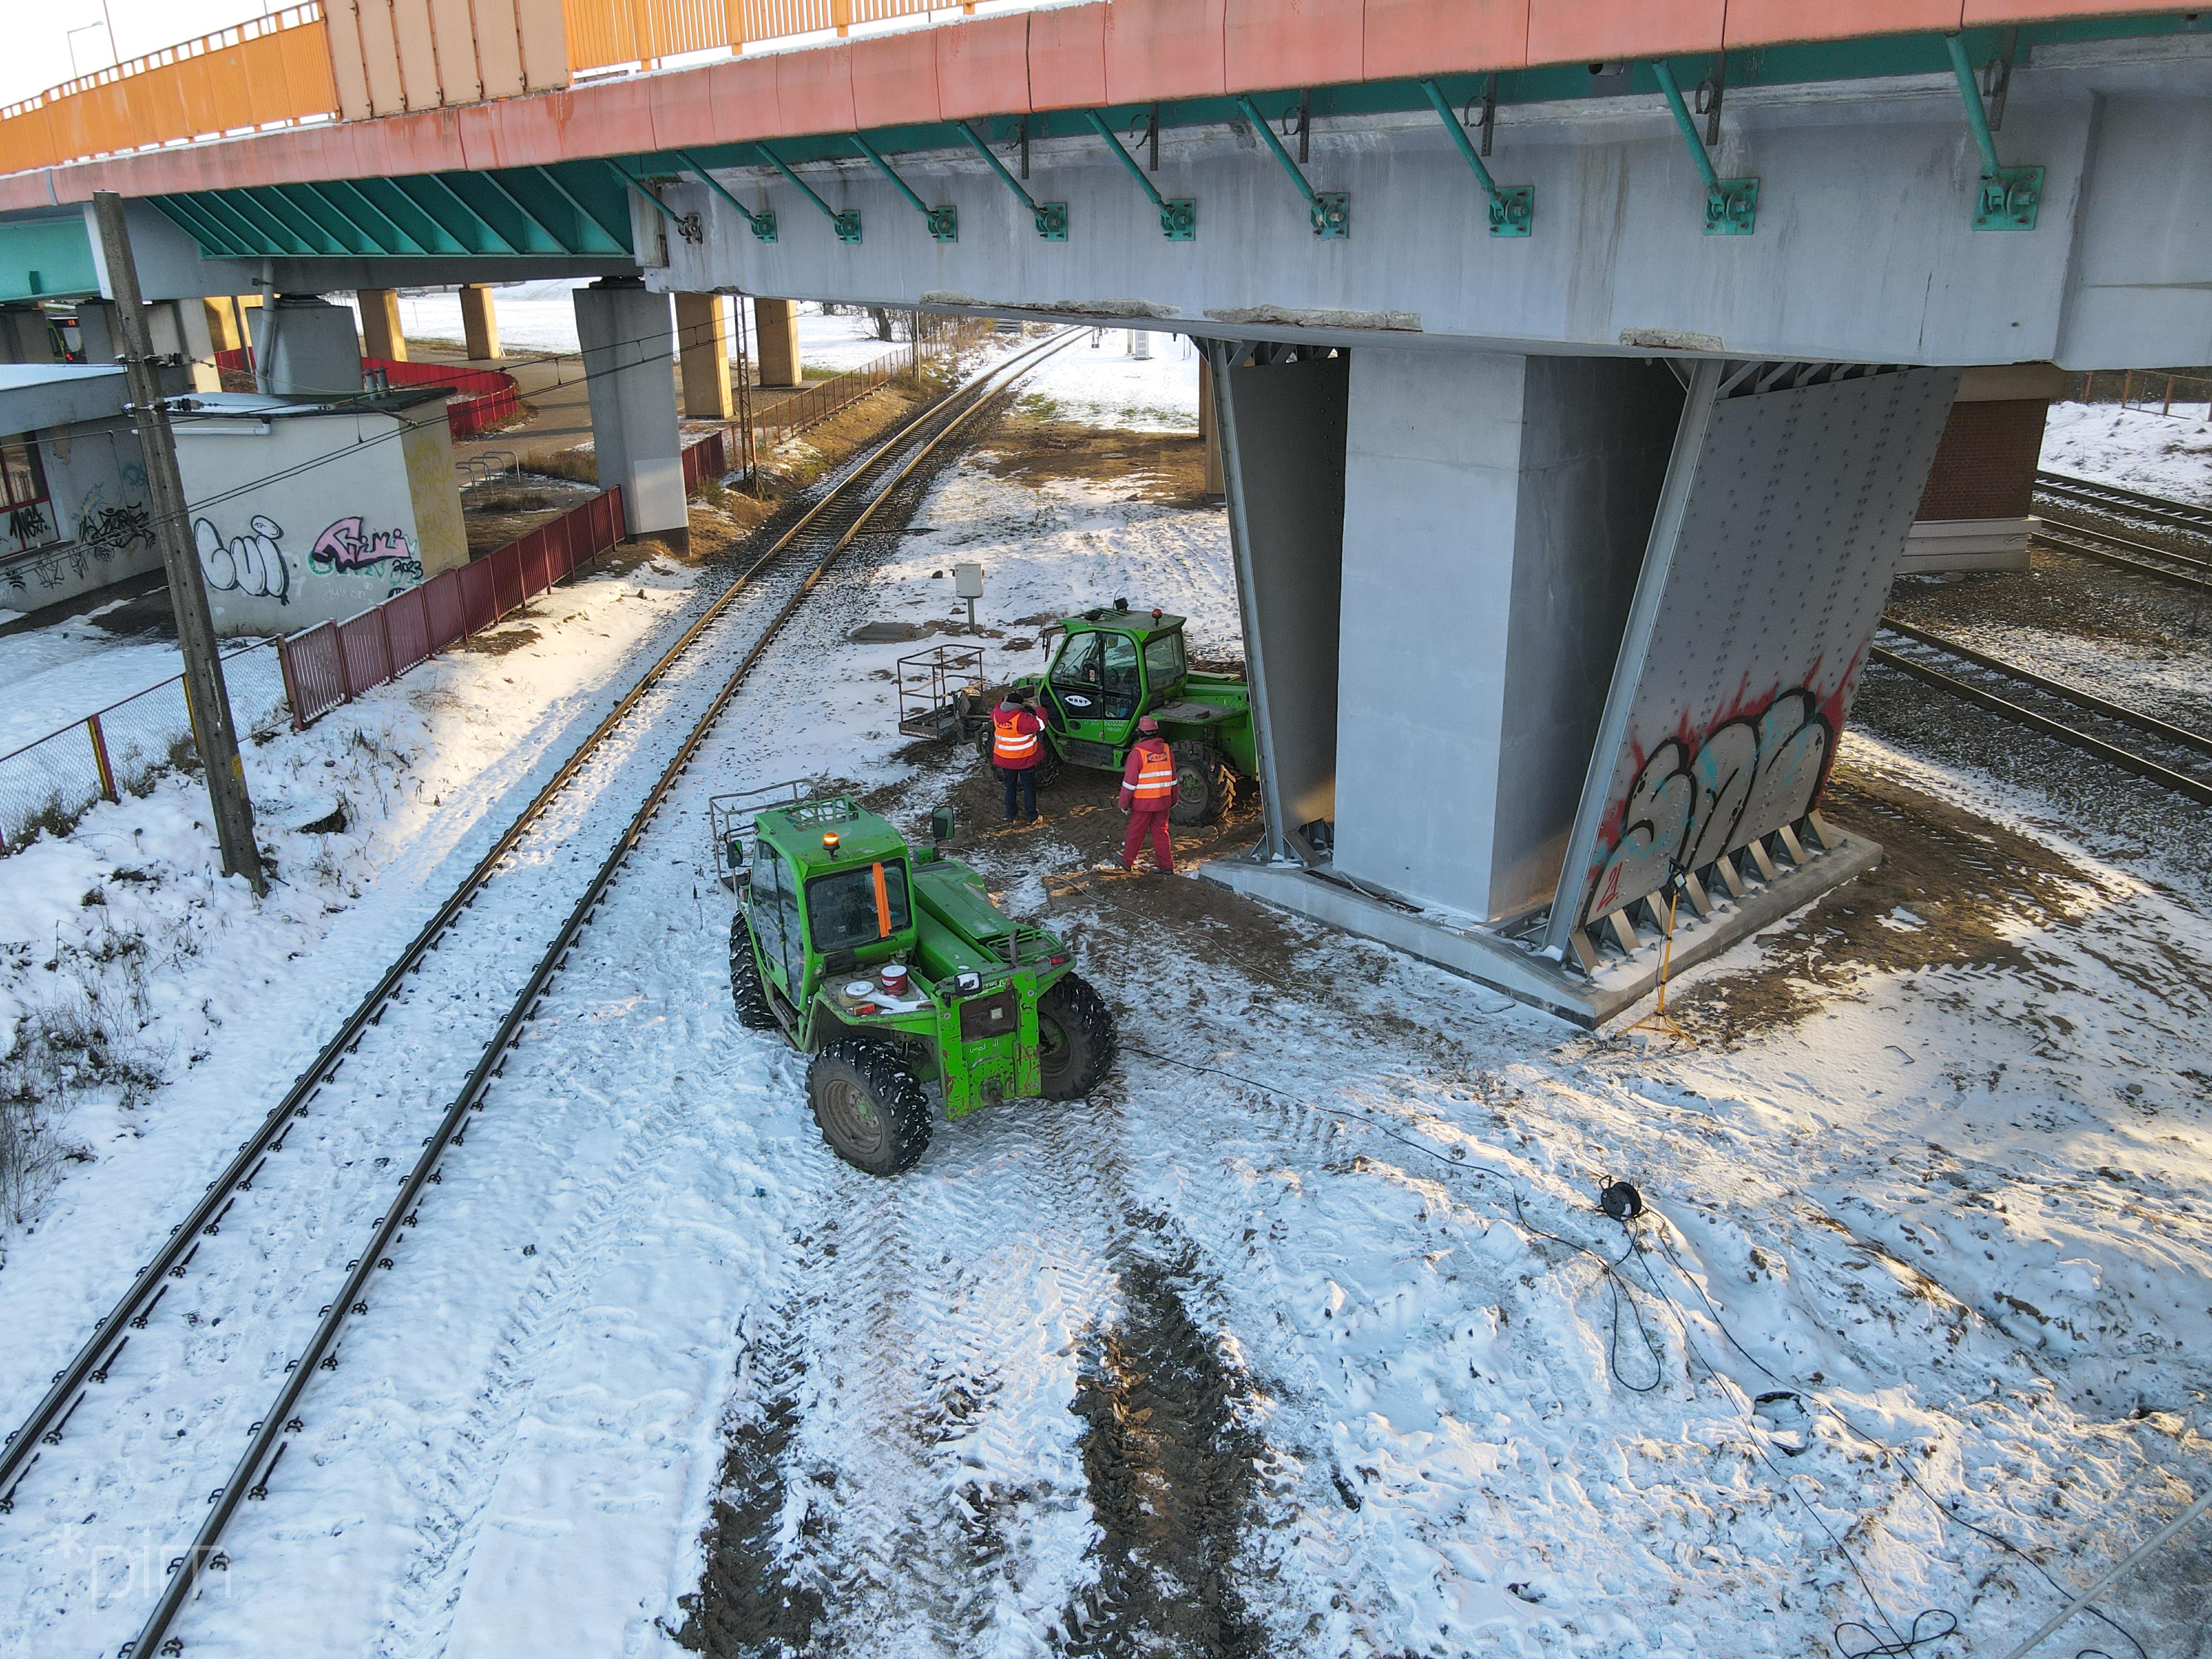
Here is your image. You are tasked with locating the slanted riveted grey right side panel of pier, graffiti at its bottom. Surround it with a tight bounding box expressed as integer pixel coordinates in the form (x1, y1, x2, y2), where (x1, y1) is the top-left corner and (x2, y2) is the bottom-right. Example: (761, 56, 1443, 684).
(1559, 365, 1958, 925)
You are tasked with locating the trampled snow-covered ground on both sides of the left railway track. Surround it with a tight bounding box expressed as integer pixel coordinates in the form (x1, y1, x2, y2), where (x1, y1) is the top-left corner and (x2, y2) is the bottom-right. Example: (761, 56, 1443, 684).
(0, 347, 2212, 1659)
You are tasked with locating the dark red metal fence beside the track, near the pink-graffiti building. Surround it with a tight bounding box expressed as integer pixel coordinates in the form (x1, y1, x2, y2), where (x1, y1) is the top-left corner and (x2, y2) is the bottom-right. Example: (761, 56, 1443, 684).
(279, 491, 628, 730)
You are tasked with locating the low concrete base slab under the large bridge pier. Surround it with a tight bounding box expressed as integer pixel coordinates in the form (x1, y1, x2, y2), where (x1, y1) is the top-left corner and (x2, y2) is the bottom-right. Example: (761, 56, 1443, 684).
(1199, 832, 1882, 1029)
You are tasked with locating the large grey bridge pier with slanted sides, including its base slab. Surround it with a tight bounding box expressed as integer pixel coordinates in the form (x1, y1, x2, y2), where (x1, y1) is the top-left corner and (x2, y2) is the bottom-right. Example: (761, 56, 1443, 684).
(1208, 343, 1958, 1024)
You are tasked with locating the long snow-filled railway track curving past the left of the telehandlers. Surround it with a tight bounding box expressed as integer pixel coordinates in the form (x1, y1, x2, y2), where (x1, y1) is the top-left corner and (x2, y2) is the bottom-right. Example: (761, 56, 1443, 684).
(0, 334, 1075, 1655)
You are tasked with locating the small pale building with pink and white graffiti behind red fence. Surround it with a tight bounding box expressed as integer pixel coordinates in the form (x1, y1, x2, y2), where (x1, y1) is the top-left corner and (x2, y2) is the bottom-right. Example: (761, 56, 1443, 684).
(177, 394, 469, 635)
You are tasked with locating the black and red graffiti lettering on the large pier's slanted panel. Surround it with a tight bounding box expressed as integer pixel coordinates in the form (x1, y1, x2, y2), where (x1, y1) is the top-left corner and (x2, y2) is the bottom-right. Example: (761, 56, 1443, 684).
(1582, 679, 1849, 925)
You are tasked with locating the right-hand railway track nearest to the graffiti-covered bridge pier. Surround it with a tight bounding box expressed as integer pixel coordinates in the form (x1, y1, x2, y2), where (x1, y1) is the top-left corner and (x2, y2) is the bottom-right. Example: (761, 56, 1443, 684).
(1871, 617, 2212, 805)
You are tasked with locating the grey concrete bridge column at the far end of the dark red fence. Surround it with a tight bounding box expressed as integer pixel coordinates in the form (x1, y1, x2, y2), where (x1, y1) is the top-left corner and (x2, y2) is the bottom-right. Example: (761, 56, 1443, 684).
(575, 276, 690, 551)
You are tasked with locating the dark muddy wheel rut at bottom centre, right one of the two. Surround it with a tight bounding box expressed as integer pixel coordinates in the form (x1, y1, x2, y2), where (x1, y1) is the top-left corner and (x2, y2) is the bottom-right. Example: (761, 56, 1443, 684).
(1057, 1254, 1267, 1659)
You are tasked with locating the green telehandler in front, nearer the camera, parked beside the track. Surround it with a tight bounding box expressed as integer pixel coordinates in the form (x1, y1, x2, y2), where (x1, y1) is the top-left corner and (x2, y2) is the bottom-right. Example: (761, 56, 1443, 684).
(708, 783, 1115, 1175)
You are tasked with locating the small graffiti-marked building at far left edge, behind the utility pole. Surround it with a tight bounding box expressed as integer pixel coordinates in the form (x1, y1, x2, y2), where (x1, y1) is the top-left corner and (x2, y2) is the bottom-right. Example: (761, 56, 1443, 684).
(0, 363, 161, 611)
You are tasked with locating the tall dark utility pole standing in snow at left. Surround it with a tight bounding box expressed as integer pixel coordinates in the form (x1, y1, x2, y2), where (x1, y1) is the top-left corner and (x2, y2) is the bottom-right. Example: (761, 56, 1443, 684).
(93, 190, 268, 896)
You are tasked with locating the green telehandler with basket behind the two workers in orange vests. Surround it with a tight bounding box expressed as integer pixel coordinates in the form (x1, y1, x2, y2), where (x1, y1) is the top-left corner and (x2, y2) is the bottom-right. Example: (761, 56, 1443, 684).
(898, 599, 1259, 823)
